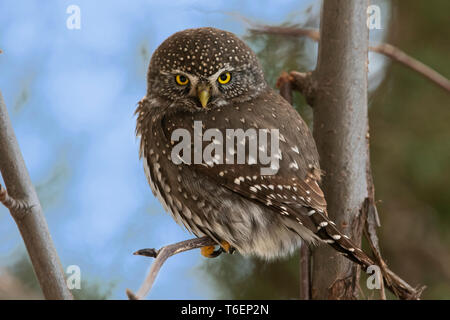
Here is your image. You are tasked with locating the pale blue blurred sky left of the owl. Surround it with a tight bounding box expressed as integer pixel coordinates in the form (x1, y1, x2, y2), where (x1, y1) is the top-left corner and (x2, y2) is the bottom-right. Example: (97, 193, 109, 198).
(0, 0, 386, 299)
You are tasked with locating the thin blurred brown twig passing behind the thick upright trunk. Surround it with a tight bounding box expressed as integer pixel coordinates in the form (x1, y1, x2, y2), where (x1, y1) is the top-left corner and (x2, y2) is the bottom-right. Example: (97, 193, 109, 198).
(249, 24, 450, 92)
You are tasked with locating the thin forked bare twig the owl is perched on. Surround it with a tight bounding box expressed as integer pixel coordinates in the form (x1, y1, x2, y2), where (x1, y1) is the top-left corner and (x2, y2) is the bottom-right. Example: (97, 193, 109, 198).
(127, 237, 217, 300)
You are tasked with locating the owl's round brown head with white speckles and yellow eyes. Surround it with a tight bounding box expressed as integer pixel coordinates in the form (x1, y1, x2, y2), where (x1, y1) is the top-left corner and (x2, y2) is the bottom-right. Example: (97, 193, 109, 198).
(147, 28, 267, 109)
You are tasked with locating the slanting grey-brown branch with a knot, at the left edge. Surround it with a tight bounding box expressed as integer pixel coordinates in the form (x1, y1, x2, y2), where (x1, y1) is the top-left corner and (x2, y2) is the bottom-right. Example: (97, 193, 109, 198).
(0, 93, 73, 299)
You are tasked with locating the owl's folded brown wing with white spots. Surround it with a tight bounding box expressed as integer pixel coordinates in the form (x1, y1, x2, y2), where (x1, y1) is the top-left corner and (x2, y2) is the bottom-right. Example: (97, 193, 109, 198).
(166, 91, 326, 229)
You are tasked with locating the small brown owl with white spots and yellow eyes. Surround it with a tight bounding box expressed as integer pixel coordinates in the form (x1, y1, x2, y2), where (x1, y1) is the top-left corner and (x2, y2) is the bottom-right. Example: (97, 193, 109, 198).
(136, 28, 370, 265)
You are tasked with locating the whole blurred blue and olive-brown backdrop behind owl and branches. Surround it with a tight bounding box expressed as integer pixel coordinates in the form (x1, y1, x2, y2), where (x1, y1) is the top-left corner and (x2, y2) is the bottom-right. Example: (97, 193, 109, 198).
(0, 0, 450, 299)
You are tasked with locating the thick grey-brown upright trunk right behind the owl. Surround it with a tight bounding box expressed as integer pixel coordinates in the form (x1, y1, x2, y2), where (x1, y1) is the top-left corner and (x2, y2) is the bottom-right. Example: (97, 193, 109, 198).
(312, 0, 369, 299)
